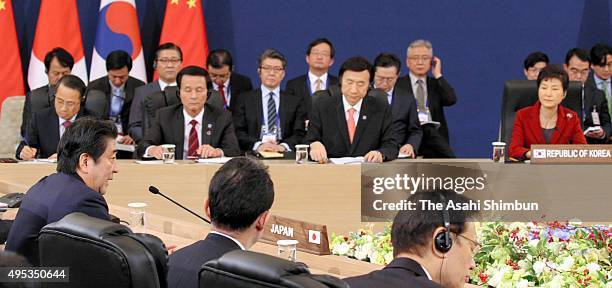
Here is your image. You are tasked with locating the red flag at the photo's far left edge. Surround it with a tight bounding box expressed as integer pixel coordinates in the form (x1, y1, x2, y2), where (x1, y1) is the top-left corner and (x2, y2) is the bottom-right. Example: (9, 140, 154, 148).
(0, 0, 25, 107)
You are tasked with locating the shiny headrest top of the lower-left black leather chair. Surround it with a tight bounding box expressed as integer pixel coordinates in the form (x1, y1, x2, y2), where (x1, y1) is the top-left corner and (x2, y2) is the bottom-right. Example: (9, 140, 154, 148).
(41, 212, 132, 240)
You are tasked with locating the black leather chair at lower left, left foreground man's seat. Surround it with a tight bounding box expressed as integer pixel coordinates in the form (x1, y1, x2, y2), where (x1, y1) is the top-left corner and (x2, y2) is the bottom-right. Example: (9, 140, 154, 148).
(38, 212, 168, 288)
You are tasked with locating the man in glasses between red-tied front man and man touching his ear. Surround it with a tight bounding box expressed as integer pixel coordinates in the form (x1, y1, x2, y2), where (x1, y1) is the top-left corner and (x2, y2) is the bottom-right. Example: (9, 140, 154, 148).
(374, 53, 423, 158)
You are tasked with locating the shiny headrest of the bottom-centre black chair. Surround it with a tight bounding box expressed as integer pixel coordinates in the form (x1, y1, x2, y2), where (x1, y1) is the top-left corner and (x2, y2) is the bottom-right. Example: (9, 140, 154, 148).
(204, 250, 310, 283)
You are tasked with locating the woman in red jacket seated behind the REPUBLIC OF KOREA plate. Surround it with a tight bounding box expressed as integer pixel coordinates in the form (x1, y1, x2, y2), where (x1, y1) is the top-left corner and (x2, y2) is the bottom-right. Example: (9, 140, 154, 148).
(509, 65, 587, 159)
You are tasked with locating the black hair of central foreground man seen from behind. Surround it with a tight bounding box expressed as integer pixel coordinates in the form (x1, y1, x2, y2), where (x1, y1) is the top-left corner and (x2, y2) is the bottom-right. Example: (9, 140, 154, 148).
(208, 157, 274, 231)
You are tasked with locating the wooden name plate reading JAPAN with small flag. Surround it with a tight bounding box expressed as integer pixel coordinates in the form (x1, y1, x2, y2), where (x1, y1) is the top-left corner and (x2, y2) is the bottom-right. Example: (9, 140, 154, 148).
(261, 215, 330, 255)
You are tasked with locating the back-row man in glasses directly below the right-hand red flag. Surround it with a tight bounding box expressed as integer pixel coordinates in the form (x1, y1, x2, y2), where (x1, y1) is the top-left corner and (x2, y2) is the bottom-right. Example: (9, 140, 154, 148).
(128, 42, 183, 143)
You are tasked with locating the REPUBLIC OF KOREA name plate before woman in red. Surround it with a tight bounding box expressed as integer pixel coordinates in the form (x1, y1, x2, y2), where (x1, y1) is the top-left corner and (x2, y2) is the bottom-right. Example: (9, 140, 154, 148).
(531, 145, 612, 164)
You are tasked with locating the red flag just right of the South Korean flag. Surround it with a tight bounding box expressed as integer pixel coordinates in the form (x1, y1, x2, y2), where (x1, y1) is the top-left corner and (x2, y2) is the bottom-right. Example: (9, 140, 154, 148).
(155, 0, 208, 78)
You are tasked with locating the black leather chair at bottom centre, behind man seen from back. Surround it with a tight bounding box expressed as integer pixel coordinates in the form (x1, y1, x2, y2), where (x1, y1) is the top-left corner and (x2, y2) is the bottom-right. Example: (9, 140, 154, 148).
(198, 250, 349, 288)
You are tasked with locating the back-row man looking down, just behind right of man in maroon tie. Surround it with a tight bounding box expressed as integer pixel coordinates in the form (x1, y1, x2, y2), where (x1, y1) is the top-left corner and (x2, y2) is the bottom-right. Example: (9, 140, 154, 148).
(206, 49, 253, 111)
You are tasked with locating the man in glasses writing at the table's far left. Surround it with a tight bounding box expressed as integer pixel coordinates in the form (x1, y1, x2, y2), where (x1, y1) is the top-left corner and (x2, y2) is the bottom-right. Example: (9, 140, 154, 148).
(15, 75, 89, 160)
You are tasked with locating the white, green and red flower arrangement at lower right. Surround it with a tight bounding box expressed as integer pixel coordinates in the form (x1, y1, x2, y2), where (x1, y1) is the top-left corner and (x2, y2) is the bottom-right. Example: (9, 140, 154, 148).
(330, 222, 612, 288)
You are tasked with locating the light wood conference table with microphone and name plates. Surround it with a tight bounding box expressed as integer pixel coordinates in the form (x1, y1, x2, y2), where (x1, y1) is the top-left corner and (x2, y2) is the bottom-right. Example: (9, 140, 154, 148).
(0, 159, 612, 277)
